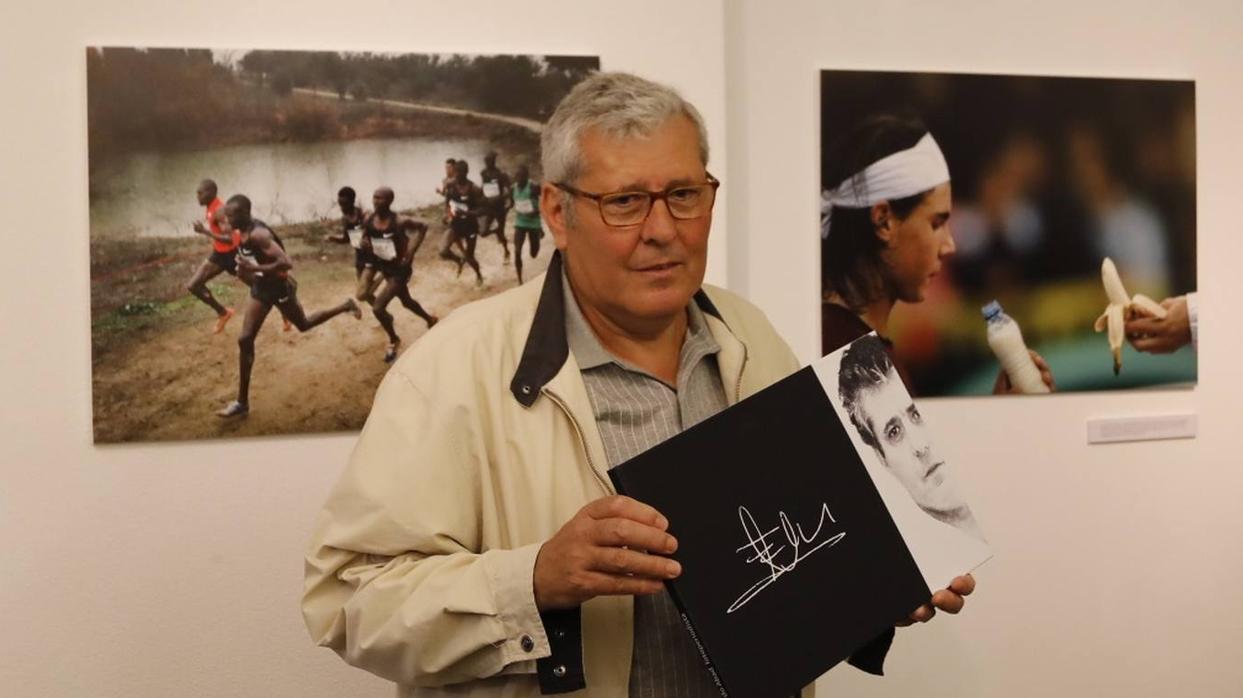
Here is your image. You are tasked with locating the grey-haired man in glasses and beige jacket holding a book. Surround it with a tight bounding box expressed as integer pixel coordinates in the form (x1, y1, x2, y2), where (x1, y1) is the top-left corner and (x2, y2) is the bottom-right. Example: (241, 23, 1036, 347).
(303, 73, 972, 698)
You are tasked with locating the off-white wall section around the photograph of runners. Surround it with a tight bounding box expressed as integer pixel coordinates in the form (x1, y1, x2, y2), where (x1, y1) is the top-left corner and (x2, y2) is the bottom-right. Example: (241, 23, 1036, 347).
(0, 0, 727, 698)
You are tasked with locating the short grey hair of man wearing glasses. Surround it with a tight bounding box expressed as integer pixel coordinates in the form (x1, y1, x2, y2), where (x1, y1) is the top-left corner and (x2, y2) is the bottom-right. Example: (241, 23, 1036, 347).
(539, 72, 707, 183)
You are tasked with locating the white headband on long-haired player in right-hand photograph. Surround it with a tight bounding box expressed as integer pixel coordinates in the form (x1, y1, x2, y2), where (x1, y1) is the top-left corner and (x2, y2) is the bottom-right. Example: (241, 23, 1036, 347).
(820, 133, 950, 238)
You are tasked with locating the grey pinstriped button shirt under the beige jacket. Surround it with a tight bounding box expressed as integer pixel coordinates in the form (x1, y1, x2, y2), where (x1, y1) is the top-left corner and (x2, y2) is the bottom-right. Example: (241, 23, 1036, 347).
(562, 271, 727, 698)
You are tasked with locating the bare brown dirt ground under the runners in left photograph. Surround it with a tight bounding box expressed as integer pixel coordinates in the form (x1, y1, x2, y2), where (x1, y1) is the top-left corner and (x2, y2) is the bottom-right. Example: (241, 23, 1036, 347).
(93, 226, 552, 443)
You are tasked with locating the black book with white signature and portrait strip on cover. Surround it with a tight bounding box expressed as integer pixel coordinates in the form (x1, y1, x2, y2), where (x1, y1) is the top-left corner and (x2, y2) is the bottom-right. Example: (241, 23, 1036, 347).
(609, 334, 991, 698)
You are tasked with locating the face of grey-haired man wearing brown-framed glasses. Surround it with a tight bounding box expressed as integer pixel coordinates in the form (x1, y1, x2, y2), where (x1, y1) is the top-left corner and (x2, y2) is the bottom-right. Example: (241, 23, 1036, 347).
(541, 116, 712, 324)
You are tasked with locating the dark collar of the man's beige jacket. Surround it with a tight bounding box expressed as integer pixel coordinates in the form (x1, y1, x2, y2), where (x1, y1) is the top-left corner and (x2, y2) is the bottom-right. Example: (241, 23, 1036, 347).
(510, 250, 725, 407)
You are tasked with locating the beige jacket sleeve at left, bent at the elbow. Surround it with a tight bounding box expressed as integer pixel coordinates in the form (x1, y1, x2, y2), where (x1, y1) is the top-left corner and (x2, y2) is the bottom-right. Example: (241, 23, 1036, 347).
(302, 366, 551, 686)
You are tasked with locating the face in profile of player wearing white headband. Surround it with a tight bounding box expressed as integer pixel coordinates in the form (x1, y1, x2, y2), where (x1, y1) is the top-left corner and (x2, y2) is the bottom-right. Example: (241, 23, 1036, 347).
(880, 183, 955, 303)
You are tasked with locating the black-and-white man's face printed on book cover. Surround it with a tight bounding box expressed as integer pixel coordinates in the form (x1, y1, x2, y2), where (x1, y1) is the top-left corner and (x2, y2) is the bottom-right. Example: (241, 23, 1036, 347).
(859, 369, 966, 513)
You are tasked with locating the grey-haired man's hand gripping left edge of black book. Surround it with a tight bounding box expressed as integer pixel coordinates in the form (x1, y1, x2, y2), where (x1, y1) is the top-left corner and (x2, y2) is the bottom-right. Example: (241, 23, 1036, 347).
(534, 496, 682, 611)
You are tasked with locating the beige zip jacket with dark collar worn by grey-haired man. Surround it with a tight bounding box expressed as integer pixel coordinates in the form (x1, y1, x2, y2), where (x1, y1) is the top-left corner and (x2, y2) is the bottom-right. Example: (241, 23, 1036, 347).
(302, 258, 810, 698)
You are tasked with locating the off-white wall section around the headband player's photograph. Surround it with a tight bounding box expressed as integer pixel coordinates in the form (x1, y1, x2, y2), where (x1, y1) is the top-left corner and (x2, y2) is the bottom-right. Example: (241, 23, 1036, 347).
(725, 0, 1243, 698)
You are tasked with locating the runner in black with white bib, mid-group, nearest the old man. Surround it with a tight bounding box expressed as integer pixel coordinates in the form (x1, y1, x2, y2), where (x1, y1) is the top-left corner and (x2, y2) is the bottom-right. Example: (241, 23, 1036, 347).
(363, 186, 439, 363)
